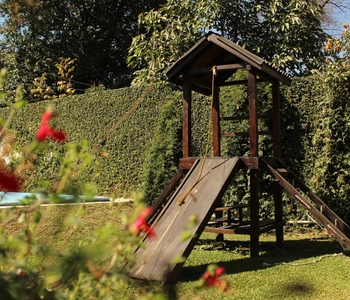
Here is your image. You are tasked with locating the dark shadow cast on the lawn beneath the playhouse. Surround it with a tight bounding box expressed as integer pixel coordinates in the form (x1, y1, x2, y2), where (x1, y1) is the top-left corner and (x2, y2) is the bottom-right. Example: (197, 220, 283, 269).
(179, 238, 342, 282)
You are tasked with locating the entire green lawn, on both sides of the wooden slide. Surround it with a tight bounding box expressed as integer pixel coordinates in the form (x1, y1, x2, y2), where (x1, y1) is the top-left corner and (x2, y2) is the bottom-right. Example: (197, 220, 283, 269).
(2, 204, 350, 300)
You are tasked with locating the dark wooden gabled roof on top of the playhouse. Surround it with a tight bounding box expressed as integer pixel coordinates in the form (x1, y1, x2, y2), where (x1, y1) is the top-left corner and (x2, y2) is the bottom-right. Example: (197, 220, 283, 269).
(165, 32, 291, 94)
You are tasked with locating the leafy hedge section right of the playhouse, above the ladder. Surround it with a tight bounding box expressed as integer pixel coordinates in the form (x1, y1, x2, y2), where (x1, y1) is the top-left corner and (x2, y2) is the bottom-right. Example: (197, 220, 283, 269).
(282, 74, 350, 222)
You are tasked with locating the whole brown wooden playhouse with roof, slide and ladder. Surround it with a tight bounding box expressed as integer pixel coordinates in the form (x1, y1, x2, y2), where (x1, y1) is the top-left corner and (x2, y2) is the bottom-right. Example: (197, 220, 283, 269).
(129, 32, 350, 283)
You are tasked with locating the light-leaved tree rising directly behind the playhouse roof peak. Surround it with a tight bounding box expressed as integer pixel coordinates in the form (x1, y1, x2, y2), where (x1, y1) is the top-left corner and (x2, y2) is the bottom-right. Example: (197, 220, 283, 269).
(128, 0, 329, 83)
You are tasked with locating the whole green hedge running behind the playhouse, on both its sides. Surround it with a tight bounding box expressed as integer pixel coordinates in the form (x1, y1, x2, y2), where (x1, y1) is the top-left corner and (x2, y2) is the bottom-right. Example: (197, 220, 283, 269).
(0, 74, 350, 221)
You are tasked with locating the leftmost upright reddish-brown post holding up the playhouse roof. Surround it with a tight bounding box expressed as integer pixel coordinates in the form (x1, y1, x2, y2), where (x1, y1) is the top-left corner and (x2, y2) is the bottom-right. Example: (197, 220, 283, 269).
(182, 80, 192, 158)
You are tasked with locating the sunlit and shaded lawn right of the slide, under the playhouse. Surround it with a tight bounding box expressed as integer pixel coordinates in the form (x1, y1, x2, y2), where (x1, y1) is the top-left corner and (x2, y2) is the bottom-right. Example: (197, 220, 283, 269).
(178, 233, 350, 300)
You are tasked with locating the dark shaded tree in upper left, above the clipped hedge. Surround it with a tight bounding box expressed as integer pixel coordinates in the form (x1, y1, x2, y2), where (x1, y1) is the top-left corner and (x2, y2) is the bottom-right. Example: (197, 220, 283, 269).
(0, 0, 164, 97)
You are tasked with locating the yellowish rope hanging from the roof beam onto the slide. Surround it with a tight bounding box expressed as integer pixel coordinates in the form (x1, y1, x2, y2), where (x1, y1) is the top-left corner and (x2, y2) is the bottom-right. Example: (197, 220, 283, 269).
(177, 66, 217, 205)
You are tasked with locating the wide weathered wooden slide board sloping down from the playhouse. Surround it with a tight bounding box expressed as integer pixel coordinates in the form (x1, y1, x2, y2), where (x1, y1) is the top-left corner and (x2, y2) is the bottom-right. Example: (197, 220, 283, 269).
(129, 157, 240, 283)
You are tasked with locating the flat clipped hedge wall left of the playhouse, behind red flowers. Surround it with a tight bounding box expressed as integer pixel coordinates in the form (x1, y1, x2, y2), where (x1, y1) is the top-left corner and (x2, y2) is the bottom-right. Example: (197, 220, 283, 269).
(0, 85, 182, 196)
